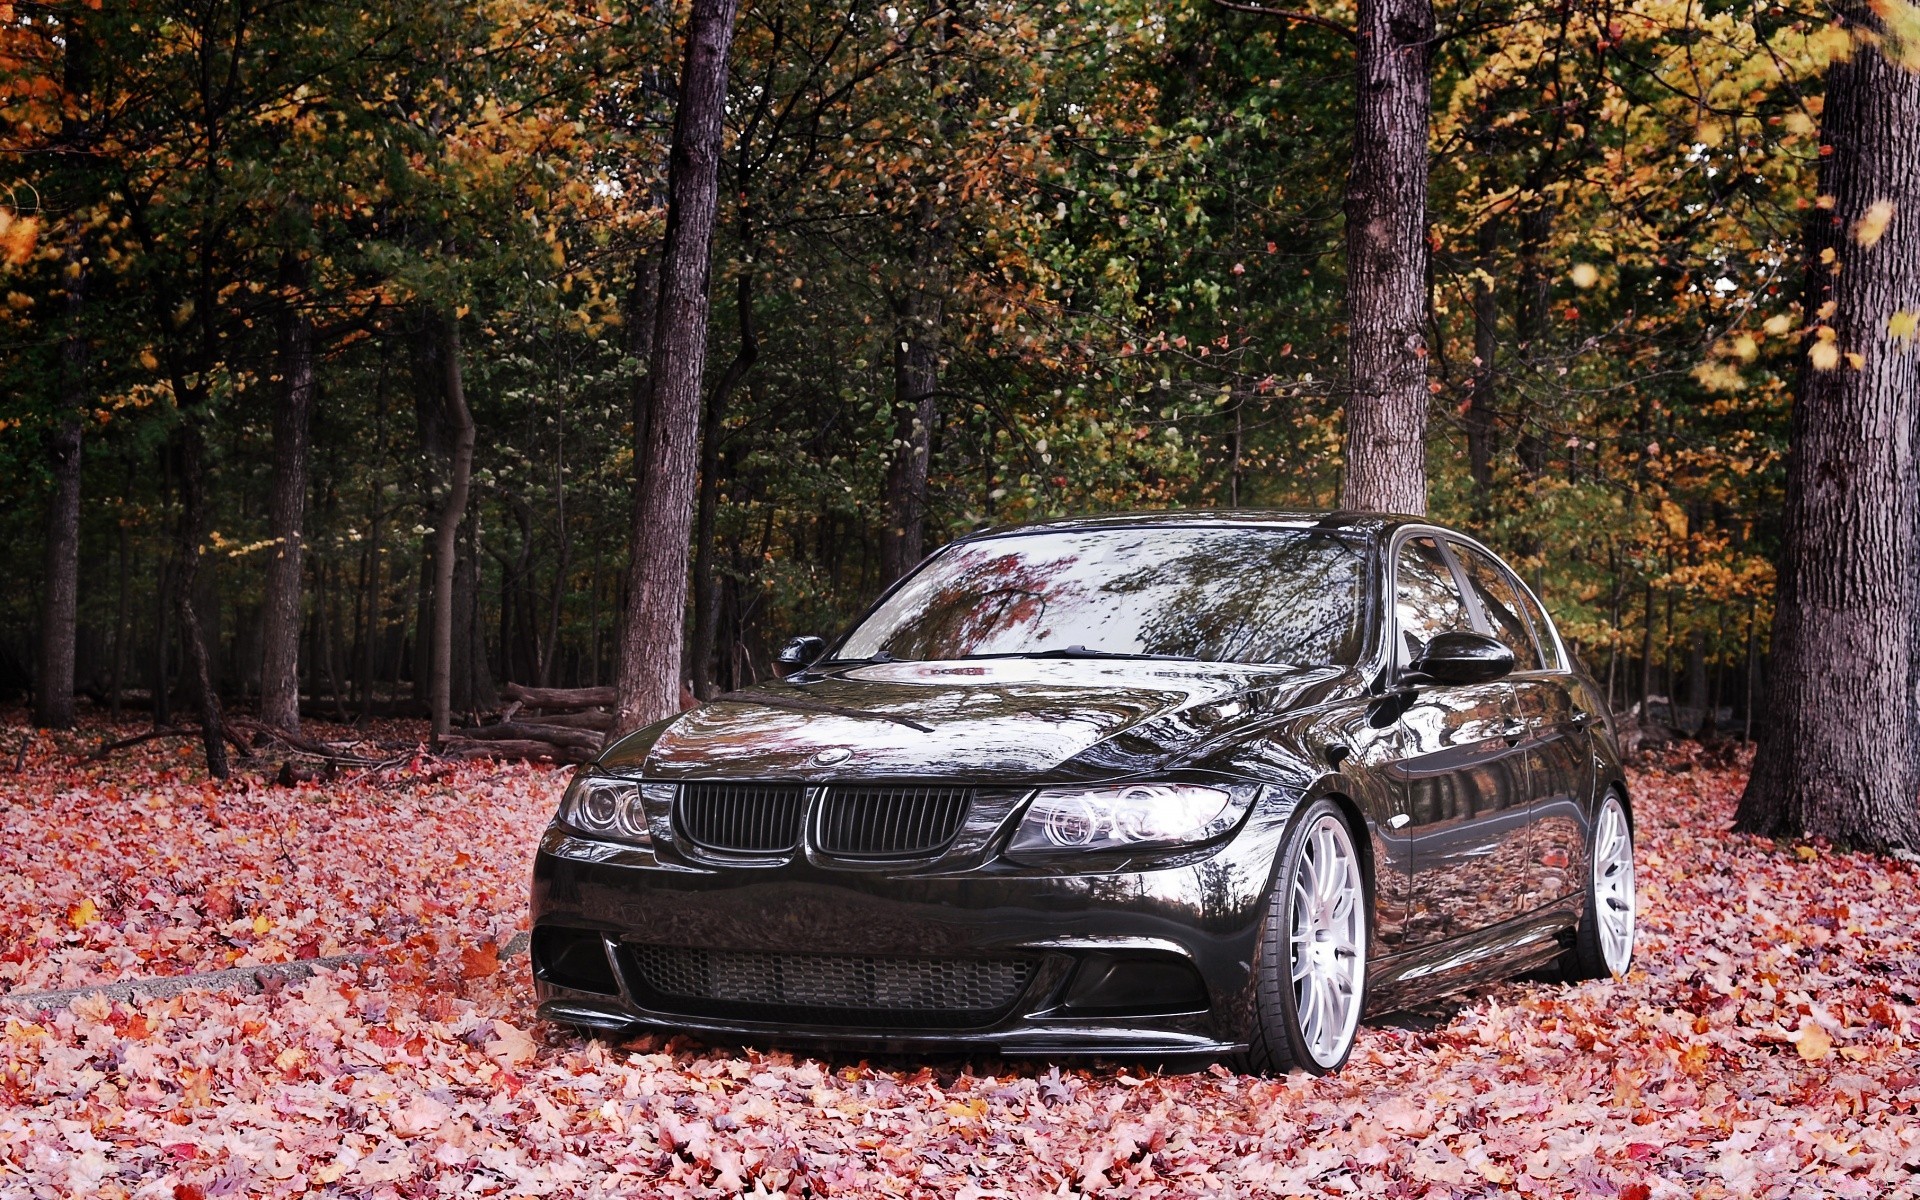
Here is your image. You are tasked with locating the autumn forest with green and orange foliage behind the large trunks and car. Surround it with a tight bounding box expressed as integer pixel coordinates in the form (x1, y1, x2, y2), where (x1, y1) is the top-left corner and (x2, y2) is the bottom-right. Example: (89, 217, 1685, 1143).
(0, 0, 1889, 794)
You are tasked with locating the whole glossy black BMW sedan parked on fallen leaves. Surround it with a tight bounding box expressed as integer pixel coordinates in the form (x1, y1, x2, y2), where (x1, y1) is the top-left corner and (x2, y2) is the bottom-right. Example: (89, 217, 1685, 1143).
(532, 511, 1634, 1071)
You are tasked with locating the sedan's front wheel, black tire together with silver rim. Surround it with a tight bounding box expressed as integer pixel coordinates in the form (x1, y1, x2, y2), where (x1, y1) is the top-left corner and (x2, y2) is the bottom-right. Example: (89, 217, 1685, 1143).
(1246, 799, 1369, 1075)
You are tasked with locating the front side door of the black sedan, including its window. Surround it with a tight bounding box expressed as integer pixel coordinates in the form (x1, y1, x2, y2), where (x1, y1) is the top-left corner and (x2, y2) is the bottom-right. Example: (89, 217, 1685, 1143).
(1388, 532, 1526, 947)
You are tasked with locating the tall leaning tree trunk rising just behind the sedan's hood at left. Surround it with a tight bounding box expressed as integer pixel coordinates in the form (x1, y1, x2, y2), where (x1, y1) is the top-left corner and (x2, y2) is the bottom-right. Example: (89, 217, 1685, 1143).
(616, 0, 739, 732)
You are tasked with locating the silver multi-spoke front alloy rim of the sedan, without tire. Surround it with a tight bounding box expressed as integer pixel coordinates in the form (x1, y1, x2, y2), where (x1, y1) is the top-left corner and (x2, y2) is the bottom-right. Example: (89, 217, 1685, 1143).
(1288, 812, 1367, 1068)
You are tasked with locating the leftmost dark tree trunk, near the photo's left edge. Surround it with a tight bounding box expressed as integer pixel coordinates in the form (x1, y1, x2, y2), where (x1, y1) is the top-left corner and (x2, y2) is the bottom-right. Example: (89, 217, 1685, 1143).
(33, 255, 86, 730)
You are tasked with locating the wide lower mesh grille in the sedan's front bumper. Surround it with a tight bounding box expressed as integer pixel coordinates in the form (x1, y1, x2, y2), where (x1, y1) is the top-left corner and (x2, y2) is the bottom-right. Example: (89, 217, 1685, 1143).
(626, 945, 1033, 1025)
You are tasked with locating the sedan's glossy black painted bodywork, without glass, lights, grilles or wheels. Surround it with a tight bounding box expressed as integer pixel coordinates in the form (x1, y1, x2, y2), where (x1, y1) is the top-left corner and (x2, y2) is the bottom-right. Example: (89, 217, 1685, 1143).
(532, 513, 1624, 1054)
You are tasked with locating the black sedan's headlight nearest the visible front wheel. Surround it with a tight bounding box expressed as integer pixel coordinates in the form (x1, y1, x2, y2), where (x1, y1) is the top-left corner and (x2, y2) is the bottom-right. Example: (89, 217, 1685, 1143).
(1006, 783, 1252, 858)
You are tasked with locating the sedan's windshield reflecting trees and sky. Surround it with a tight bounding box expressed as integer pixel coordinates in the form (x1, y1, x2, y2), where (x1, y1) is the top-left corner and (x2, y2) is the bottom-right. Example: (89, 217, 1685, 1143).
(835, 526, 1365, 666)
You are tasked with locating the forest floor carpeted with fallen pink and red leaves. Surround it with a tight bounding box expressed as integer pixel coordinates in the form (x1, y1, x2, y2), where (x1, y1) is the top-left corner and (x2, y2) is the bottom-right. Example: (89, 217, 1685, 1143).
(0, 714, 1920, 1200)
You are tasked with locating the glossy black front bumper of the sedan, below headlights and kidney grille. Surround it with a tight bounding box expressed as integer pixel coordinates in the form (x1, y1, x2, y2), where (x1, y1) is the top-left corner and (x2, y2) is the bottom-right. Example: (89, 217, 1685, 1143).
(532, 812, 1281, 1056)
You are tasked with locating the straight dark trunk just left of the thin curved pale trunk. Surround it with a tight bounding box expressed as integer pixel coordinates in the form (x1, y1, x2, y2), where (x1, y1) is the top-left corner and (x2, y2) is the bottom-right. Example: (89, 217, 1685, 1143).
(259, 253, 313, 733)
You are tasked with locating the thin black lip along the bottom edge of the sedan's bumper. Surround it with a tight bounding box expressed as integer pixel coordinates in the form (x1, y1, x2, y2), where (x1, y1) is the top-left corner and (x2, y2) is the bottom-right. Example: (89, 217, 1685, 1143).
(540, 996, 1246, 1058)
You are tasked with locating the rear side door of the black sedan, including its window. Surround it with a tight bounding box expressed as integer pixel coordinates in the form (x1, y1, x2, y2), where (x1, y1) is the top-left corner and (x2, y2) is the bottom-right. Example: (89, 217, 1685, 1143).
(1452, 540, 1592, 910)
